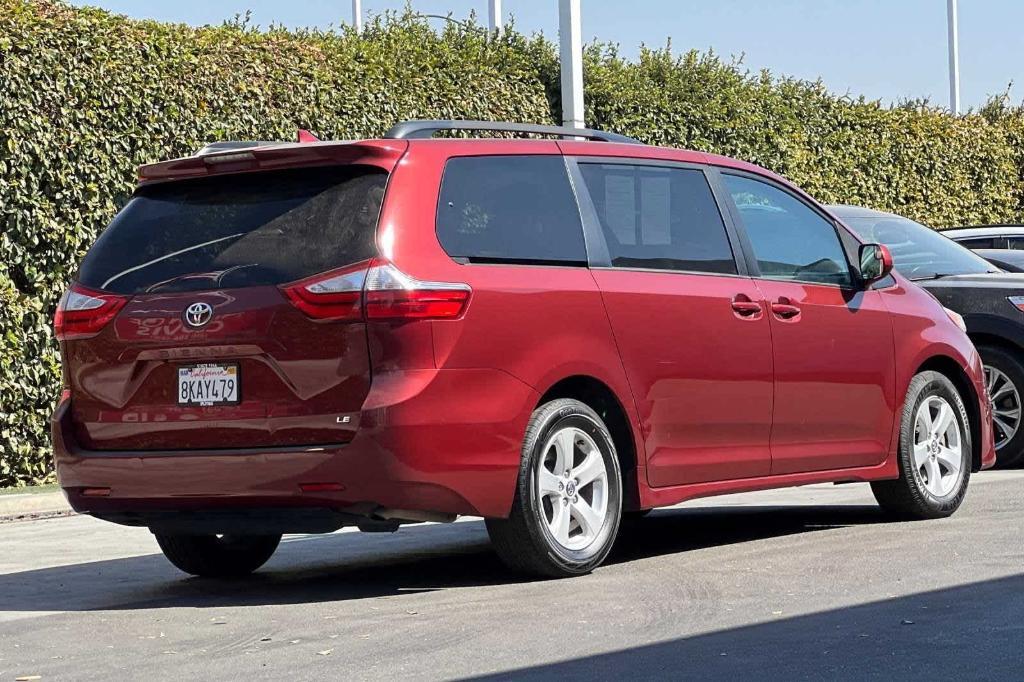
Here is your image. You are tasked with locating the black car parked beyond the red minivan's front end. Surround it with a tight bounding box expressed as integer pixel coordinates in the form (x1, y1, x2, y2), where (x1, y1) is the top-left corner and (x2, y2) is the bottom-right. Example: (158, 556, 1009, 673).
(828, 206, 1024, 467)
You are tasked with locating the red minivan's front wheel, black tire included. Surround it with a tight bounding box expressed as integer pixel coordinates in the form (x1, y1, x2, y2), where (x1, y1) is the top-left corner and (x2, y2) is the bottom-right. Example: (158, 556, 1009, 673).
(871, 372, 972, 519)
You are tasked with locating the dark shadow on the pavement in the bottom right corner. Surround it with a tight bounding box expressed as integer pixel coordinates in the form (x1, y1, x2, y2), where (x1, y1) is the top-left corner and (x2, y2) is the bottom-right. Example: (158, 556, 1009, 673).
(473, 574, 1024, 682)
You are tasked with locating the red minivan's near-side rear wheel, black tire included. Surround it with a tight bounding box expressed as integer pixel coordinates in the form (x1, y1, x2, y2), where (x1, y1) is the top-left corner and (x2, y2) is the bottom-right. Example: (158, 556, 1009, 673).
(486, 398, 623, 578)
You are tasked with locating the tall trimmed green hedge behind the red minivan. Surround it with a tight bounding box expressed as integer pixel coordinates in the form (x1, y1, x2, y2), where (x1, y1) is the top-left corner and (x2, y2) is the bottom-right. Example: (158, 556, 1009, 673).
(0, 0, 1024, 485)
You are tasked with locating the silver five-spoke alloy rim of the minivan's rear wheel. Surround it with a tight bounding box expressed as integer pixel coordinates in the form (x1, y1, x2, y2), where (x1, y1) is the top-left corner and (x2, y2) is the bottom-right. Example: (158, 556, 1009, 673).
(536, 426, 609, 550)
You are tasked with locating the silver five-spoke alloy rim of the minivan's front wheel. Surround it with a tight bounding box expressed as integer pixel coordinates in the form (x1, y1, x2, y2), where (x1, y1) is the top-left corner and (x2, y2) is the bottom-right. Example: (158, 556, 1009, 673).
(913, 395, 964, 498)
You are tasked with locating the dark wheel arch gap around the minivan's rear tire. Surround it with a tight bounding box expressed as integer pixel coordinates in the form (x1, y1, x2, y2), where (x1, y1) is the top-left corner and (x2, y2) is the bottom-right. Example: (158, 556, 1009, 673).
(537, 374, 640, 511)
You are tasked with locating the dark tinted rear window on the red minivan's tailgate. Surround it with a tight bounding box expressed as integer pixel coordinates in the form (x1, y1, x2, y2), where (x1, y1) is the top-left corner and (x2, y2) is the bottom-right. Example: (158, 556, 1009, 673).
(79, 166, 387, 294)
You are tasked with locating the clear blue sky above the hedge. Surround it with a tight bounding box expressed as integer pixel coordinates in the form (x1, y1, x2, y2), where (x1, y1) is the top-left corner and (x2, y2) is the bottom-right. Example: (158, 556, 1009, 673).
(73, 0, 1024, 108)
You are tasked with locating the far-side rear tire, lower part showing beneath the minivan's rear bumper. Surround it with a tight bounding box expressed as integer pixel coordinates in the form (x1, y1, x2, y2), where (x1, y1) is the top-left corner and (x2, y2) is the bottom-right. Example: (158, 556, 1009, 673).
(156, 534, 281, 578)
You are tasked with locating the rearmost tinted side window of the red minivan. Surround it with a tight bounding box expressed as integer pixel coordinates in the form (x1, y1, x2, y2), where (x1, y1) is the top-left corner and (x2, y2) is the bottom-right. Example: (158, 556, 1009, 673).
(437, 156, 587, 264)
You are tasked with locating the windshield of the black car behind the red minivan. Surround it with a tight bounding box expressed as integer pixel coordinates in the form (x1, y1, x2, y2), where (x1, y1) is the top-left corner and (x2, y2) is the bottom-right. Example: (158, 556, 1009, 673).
(841, 215, 998, 280)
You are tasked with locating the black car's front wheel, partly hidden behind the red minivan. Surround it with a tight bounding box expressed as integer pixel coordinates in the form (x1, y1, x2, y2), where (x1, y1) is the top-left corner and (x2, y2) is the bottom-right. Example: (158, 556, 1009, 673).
(978, 345, 1024, 468)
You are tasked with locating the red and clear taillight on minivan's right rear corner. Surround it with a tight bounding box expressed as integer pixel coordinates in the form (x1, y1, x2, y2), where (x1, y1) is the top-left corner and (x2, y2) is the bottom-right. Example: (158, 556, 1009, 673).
(282, 258, 470, 321)
